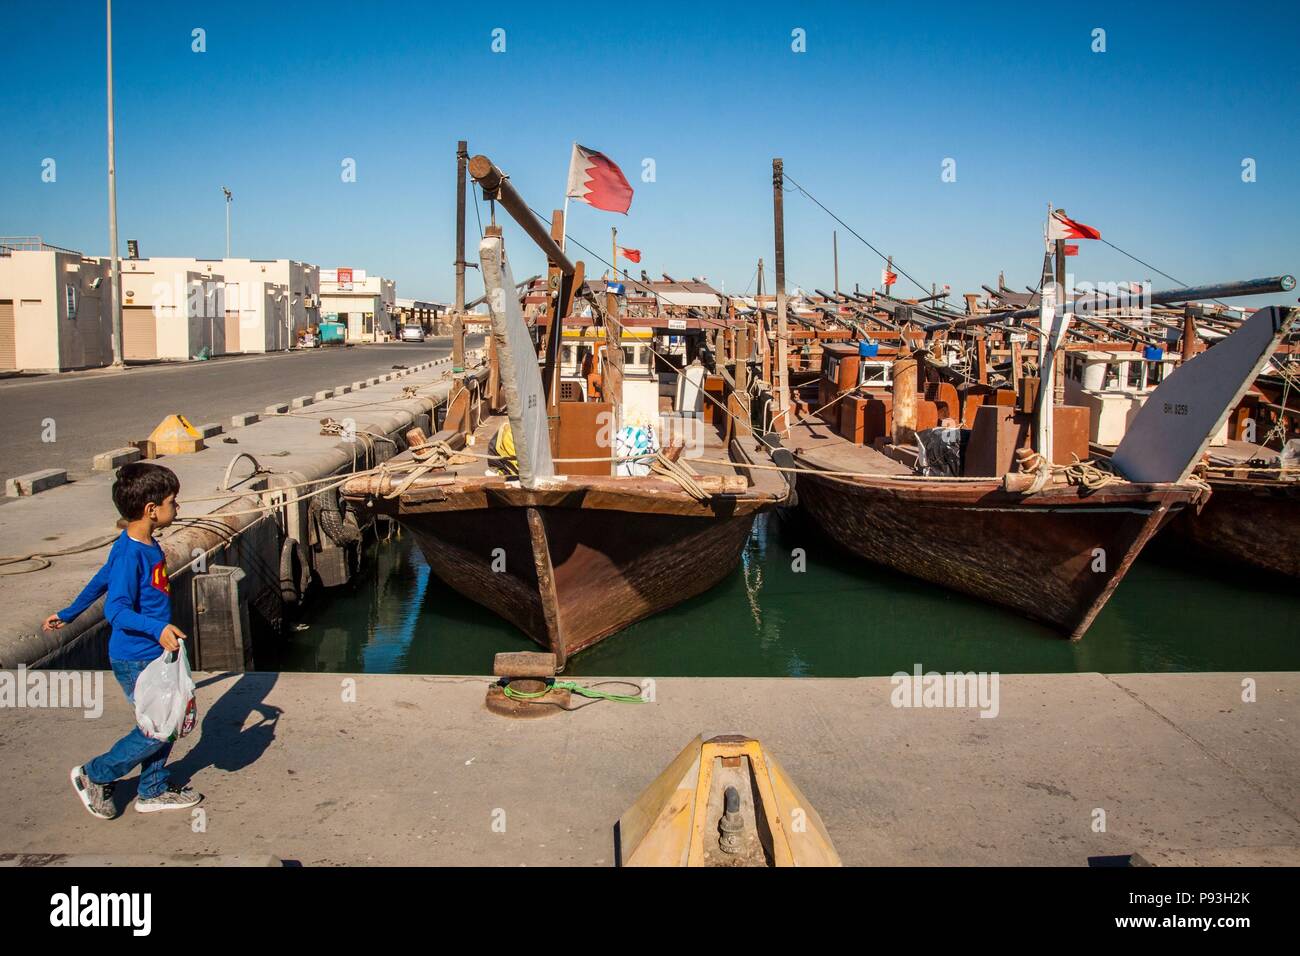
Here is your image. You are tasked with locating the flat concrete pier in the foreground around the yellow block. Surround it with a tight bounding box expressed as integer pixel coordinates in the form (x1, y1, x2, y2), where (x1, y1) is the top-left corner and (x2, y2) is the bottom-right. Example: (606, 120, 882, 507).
(0, 672, 1300, 866)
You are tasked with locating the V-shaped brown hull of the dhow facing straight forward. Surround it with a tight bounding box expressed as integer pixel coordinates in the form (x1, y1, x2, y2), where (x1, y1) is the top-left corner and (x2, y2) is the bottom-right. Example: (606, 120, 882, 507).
(400, 506, 754, 666)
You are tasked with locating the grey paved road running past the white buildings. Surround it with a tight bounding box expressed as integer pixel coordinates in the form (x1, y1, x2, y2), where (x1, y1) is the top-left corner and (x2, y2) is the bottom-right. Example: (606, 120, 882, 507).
(0, 337, 481, 502)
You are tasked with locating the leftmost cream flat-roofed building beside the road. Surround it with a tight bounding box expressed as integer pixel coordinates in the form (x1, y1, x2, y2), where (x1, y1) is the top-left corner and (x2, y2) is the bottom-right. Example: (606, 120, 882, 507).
(0, 238, 113, 371)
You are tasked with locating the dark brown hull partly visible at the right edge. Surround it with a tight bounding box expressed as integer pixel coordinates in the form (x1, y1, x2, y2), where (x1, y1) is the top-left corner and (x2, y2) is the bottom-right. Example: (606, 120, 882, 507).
(1169, 479, 1300, 578)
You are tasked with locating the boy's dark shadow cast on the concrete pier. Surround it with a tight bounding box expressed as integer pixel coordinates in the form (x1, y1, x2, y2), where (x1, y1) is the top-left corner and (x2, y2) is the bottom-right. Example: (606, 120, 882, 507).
(168, 672, 283, 786)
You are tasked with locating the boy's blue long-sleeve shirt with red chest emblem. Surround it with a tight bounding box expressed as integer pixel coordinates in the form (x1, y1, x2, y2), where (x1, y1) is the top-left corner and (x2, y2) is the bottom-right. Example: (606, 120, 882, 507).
(59, 531, 172, 661)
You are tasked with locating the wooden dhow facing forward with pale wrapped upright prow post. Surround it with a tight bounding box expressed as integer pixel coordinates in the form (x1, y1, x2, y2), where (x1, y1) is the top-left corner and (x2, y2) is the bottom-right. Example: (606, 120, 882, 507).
(342, 156, 789, 667)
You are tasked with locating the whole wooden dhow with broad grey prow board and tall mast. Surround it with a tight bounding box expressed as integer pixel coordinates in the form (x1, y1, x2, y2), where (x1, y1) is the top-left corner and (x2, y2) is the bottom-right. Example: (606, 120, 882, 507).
(772, 160, 1294, 640)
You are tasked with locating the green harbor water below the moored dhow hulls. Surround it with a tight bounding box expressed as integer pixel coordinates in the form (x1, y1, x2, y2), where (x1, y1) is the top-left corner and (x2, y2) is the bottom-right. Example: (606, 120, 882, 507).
(256, 514, 1300, 678)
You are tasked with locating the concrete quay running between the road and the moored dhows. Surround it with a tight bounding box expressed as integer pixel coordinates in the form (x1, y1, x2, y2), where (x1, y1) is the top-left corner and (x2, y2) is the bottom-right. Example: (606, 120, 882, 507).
(0, 352, 477, 667)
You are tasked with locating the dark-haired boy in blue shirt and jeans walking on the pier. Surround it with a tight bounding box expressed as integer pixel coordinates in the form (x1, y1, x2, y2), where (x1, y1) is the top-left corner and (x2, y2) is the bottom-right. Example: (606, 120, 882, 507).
(44, 462, 203, 819)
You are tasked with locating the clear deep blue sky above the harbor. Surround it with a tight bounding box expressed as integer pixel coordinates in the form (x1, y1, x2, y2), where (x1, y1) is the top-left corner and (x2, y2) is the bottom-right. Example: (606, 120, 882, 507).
(0, 0, 1300, 302)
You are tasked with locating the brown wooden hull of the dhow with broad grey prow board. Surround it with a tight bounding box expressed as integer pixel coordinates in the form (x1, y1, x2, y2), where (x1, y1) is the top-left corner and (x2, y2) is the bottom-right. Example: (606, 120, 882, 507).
(798, 472, 1193, 640)
